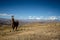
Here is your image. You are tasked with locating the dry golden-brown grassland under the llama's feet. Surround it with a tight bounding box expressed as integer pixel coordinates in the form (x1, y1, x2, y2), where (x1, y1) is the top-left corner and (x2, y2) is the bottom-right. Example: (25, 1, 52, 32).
(0, 22, 60, 40)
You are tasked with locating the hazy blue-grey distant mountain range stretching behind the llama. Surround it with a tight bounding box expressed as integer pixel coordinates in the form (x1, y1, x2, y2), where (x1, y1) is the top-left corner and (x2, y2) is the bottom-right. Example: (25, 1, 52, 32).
(0, 18, 60, 25)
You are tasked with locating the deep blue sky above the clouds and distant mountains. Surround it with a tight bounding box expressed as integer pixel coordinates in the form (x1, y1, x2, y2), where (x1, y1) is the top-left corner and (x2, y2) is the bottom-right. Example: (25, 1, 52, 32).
(0, 0, 60, 19)
